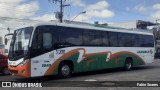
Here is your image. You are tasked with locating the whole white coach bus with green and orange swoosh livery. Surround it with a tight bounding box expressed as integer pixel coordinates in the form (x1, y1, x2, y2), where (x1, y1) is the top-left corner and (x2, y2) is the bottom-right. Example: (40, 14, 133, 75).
(8, 23, 154, 77)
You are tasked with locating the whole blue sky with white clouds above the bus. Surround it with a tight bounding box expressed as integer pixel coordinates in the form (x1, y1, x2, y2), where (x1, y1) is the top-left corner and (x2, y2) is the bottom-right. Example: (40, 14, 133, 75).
(0, 0, 160, 29)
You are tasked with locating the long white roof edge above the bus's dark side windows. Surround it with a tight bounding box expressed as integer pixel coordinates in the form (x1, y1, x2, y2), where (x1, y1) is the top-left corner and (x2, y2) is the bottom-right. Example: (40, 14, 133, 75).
(33, 22, 153, 35)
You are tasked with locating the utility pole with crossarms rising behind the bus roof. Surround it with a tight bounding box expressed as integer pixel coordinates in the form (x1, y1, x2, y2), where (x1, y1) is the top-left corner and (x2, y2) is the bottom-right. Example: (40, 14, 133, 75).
(48, 0, 70, 23)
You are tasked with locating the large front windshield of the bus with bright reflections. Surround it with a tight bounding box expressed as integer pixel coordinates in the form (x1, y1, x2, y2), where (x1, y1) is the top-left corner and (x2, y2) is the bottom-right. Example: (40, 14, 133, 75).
(9, 27, 33, 60)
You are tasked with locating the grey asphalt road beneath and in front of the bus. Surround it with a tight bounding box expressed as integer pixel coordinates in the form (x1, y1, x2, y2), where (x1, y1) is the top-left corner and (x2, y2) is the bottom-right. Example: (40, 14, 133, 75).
(0, 59, 160, 90)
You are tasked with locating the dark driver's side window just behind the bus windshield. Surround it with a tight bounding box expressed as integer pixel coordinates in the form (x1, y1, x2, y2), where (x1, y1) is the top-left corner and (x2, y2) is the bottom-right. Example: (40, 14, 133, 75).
(31, 26, 53, 56)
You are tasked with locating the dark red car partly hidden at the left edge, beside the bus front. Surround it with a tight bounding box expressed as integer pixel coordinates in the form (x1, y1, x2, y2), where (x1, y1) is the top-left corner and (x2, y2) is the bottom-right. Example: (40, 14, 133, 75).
(0, 54, 9, 74)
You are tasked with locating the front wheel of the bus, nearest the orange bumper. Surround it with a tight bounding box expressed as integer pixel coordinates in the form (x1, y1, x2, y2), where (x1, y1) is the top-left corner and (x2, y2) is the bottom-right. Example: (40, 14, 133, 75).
(58, 63, 72, 78)
